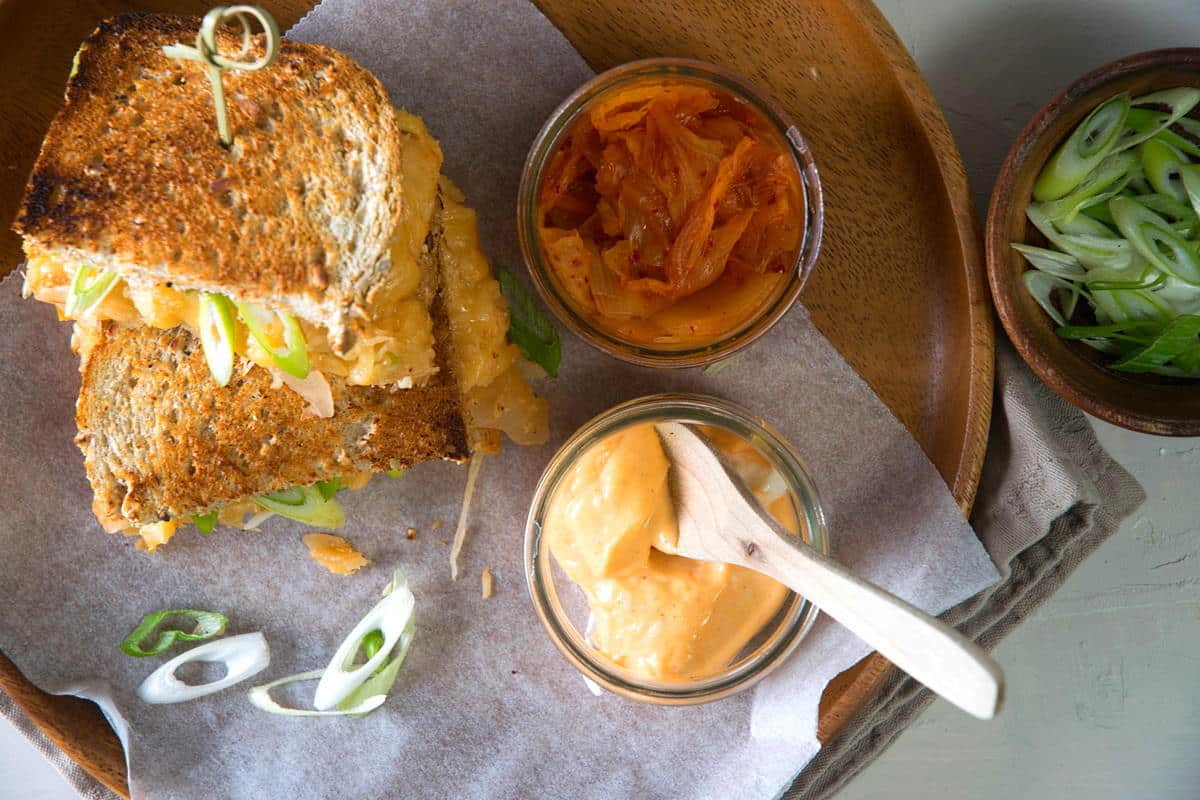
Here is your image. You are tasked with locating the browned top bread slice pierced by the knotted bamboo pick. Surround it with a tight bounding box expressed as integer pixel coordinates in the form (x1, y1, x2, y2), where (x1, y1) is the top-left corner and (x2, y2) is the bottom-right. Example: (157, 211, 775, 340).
(13, 14, 401, 351)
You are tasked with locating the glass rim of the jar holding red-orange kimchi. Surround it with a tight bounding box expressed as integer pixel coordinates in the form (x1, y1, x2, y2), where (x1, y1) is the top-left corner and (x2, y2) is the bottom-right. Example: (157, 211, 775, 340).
(517, 58, 824, 368)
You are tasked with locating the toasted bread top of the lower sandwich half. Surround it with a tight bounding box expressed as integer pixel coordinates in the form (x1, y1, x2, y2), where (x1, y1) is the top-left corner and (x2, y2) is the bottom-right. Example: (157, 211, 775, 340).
(76, 323, 469, 527)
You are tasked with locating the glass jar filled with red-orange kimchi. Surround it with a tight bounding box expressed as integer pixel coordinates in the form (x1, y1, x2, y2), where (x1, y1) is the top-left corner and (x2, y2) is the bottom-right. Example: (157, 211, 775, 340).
(517, 59, 824, 367)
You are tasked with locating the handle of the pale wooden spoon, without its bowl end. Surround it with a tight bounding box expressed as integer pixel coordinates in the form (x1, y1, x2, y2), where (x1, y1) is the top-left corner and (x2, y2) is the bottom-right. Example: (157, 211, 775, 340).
(744, 521, 1004, 720)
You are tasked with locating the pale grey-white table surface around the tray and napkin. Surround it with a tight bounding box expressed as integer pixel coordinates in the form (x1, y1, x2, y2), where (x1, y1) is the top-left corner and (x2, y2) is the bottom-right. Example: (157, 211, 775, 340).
(7, 0, 1200, 800)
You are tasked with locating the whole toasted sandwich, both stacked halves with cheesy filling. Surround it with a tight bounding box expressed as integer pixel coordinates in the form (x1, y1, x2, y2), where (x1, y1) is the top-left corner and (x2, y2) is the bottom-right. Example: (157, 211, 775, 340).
(16, 16, 548, 551)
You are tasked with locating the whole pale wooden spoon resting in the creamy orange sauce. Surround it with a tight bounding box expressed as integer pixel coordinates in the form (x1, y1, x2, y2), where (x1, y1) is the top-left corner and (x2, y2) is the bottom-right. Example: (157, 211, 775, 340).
(655, 422, 1004, 720)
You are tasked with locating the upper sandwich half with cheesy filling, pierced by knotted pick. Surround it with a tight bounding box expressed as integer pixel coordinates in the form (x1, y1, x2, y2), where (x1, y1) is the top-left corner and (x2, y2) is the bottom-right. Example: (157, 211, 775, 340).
(14, 14, 442, 387)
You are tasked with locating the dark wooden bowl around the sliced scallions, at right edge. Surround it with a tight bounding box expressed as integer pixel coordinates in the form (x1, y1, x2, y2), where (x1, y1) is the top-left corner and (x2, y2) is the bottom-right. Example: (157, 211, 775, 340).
(986, 47, 1200, 437)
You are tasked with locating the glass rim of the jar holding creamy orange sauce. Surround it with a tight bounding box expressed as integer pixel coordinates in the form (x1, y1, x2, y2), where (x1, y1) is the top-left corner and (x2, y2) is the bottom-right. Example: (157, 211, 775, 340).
(524, 393, 829, 705)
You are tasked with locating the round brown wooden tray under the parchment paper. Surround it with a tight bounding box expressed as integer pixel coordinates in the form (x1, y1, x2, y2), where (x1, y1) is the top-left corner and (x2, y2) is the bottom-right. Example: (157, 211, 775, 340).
(0, 0, 994, 796)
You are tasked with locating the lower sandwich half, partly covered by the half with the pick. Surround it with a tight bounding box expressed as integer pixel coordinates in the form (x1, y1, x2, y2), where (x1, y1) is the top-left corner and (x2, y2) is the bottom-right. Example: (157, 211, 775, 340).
(76, 179, 548, 537)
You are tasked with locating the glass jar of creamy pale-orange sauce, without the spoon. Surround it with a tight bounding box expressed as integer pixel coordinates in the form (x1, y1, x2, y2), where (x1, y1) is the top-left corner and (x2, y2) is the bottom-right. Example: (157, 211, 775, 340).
(524, 395, 829, 705)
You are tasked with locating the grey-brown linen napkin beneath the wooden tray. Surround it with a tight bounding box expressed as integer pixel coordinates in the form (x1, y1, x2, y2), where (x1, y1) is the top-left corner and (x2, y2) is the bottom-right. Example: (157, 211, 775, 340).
(0, 339, 1146, 800)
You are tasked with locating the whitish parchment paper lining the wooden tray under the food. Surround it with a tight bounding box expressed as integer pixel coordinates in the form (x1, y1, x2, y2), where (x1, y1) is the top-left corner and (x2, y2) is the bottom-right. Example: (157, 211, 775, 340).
(0, 0, 997, 800)
